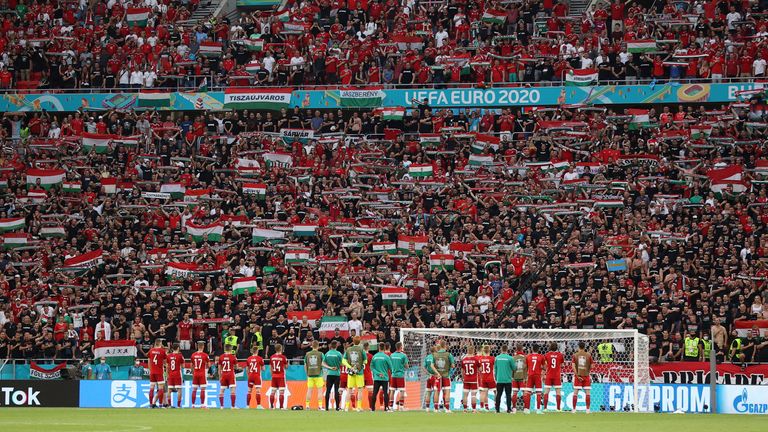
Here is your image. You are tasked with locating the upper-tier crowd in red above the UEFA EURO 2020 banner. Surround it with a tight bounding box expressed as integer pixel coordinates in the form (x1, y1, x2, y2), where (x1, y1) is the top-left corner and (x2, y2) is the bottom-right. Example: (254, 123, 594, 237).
(0, 0, 768, 89)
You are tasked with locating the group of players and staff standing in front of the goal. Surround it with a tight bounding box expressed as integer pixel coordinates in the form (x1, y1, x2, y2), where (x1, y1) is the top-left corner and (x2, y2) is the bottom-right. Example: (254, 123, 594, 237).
(432, 342, 592, 414)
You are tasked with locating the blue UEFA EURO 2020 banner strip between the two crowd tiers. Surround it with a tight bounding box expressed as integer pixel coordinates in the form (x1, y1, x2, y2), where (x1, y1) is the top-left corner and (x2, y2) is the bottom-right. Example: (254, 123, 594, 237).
(0, 82, 762, 112)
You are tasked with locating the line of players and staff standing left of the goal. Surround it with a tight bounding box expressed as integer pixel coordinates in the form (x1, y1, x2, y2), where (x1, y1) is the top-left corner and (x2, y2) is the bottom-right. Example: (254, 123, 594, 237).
(142, 337, 408, 411)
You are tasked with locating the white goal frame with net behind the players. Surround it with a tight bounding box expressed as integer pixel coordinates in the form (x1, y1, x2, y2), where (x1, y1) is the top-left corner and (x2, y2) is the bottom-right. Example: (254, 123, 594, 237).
(400, 328, 653, 412)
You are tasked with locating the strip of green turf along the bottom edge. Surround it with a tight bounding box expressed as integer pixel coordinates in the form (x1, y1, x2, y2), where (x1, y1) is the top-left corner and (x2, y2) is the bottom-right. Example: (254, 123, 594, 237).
(0, 408, 768, 432)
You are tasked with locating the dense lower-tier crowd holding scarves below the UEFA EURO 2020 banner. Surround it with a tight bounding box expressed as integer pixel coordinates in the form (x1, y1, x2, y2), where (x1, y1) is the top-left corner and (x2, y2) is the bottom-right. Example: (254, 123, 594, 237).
(0, 88, 768, 368)
